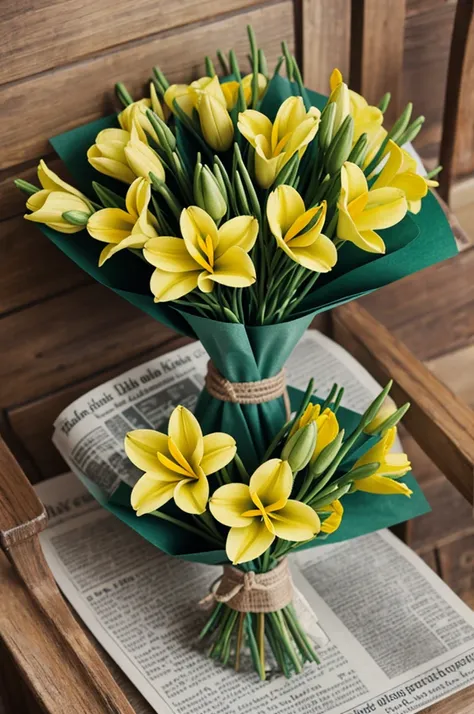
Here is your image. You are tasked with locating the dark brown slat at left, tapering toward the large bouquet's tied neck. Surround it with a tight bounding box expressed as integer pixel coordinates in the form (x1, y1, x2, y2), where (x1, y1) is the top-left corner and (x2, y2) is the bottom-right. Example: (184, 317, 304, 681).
(0, 284, 173, 406)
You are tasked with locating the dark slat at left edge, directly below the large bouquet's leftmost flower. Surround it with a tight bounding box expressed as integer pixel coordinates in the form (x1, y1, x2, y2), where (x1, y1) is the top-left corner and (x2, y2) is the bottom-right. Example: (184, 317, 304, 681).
(0, 216, 92, 312)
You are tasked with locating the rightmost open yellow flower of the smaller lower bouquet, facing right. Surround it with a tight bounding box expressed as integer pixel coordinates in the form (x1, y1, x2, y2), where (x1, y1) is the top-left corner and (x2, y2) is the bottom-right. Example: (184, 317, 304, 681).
(353, 426, 413, 496)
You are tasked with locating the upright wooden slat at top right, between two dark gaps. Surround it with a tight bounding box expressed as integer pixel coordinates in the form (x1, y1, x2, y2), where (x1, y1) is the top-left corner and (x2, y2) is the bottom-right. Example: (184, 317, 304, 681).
(350, 0, 405, 123)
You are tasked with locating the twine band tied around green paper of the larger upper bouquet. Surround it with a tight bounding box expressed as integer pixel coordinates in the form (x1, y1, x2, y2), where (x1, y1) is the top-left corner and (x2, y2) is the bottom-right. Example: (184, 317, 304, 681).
(205, 361, 291, 418)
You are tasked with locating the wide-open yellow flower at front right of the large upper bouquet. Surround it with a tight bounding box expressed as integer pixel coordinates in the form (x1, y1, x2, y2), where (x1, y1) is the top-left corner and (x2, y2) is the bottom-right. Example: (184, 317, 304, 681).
(337, 161, 408, 253)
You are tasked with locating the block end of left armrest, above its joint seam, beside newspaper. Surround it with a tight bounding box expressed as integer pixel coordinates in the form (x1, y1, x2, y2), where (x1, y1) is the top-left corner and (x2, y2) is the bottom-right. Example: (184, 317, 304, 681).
(0, 438, 46, 550)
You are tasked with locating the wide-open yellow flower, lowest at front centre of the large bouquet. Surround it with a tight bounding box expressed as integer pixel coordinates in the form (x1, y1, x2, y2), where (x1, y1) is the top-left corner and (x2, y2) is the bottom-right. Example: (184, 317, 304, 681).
(143, 206, 258, 302)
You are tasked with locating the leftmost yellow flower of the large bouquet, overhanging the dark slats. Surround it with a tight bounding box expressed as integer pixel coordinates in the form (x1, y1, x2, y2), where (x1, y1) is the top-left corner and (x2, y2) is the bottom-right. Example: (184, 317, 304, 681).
(25, 159, 93, 233)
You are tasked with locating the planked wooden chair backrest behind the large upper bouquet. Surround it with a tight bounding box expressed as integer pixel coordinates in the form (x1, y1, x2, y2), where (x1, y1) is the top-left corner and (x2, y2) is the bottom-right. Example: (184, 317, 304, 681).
(0, 0, 474, 480)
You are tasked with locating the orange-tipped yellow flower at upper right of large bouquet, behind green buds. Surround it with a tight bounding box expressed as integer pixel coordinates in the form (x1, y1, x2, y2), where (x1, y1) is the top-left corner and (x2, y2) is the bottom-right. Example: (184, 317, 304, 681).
(329, 69, 387, 166)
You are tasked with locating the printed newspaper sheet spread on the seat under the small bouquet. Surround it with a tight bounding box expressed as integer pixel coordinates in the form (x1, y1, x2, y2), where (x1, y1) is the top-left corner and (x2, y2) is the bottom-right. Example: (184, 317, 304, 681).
(45, 331, 474, 714)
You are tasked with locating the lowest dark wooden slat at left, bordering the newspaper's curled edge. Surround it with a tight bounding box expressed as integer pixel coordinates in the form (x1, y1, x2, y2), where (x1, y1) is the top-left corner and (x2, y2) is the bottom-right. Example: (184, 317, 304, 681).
(7, 326, 189, 482)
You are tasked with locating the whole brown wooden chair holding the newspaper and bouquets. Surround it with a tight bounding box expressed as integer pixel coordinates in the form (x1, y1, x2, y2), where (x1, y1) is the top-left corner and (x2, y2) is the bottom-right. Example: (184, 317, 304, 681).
(0, 0, 474, 714)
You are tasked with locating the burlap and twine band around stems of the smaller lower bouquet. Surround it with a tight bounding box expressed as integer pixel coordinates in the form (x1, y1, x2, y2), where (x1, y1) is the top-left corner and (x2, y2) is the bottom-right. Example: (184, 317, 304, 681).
(199, 558, 293, 612)
